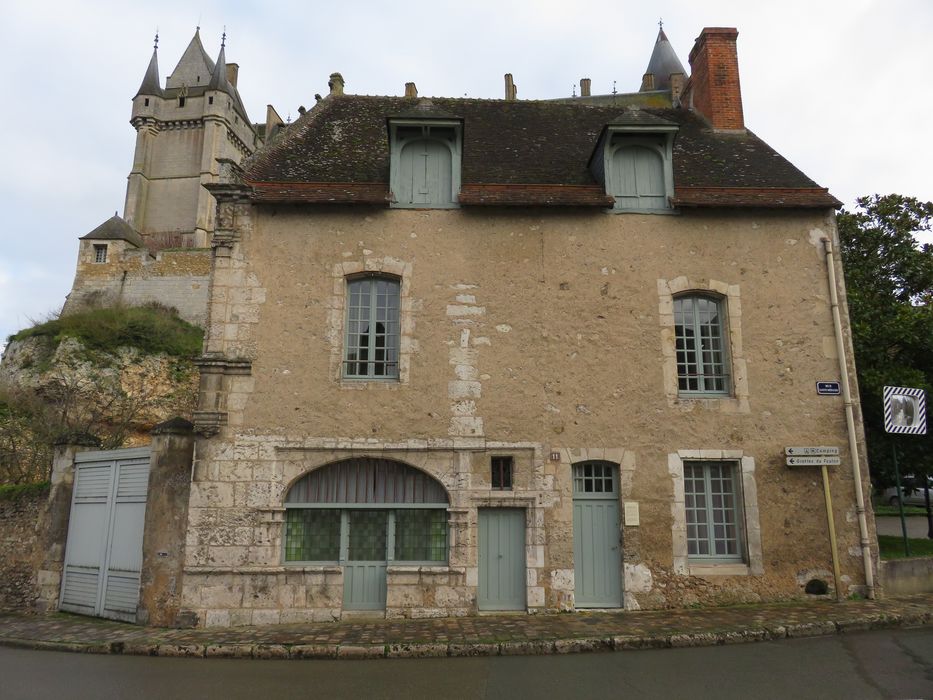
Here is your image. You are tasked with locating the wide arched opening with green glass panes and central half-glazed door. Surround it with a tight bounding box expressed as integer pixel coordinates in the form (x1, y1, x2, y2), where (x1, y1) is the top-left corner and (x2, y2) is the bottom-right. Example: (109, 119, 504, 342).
(283, 457, 449, 610)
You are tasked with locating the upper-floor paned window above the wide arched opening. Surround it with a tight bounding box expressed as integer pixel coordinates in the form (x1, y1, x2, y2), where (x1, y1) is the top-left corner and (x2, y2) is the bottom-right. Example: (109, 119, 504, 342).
(343, 276, 401, 380)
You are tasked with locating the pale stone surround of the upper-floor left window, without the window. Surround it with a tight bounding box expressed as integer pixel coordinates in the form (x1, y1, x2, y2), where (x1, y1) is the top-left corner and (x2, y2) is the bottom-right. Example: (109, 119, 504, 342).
(327, 256, 415, 390)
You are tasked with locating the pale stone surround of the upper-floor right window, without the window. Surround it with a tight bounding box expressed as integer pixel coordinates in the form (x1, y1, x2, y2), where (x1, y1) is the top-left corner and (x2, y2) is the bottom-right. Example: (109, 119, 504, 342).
(658, 275, 751, 413)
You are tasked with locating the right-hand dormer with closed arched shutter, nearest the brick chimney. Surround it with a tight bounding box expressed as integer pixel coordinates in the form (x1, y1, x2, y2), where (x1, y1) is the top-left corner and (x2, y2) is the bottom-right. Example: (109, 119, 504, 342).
(591, 117, 677, 214)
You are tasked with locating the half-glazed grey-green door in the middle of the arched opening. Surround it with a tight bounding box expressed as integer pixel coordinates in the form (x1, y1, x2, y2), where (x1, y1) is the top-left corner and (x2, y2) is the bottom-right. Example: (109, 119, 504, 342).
(343, 510, 389, 610)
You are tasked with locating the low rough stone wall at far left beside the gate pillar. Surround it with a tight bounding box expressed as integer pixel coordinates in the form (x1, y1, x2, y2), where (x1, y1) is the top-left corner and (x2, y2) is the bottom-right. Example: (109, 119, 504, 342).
(0, 488, 49, 612)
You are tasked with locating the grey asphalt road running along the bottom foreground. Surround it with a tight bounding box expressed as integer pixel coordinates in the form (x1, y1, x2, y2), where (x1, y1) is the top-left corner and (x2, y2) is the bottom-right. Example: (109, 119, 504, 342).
(0, 627, 933, 700)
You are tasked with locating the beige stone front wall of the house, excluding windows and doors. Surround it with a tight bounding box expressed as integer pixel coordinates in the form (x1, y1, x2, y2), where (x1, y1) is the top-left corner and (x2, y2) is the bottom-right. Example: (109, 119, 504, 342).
(178, 205, 871, 624)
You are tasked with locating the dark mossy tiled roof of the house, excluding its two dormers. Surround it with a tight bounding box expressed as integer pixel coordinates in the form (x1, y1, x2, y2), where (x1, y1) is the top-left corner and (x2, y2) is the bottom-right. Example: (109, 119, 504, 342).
(244, 95, 836, 207)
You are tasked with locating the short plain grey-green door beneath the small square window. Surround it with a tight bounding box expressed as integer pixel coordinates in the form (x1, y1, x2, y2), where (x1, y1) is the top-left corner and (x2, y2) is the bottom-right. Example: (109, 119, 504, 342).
(477, 508, 526, 610)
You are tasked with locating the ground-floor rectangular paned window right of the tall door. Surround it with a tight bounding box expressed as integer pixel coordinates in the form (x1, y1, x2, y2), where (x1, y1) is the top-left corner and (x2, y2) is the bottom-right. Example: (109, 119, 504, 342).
(684, 462, 743, 561)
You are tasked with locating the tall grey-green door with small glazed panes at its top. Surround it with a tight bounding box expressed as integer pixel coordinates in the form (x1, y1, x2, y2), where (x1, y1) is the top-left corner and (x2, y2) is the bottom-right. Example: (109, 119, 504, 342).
(573, 462, 622, 608)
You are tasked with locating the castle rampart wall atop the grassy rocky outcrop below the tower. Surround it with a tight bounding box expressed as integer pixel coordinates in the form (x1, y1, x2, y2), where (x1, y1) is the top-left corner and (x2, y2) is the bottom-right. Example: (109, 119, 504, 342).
(63, 245, 210, 327)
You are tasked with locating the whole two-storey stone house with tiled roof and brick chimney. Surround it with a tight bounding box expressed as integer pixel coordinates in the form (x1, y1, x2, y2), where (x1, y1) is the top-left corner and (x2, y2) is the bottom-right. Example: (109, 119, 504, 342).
(169, 28, 876, 626)
